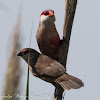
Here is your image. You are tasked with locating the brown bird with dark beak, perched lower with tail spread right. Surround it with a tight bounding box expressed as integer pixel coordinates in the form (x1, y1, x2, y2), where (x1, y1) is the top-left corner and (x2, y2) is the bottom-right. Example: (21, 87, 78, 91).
(17, 48, 84, 90)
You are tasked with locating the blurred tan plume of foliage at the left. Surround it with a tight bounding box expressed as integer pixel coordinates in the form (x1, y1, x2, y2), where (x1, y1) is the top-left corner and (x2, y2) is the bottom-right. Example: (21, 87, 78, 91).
(3, 9, 22, 100)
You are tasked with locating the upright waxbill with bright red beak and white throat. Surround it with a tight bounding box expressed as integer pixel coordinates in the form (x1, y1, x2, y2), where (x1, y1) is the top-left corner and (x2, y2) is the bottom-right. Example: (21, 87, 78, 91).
(36, 10, 60, 60)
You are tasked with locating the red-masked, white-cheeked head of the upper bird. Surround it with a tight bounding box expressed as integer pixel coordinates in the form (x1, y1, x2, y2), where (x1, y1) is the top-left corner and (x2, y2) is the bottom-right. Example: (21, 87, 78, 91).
(40, 10, 55, 23)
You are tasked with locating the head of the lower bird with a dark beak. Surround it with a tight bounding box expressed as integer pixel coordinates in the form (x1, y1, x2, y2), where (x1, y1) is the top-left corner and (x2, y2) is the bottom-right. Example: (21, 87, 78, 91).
(17, 48, 39, 63)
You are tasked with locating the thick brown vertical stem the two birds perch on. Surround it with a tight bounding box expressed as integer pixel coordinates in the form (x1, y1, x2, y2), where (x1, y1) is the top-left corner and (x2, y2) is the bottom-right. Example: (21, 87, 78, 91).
(54, 0, 77, 100)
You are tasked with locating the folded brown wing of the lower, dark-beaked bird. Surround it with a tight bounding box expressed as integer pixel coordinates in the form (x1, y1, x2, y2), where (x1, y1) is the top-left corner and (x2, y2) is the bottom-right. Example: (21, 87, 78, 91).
(35, 55, 65, 77)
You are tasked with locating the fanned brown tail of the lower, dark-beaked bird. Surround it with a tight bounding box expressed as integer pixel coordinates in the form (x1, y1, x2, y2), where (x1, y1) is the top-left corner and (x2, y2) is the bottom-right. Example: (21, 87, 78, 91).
(55, 74, 84, 90)
